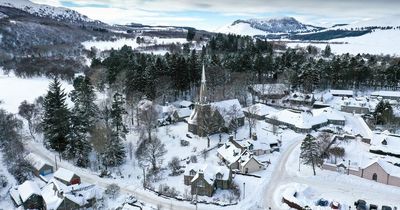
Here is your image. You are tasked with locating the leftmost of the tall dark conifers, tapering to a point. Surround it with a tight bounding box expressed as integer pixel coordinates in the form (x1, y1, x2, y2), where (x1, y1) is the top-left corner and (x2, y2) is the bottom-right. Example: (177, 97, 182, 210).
(43, 77, 70, 153)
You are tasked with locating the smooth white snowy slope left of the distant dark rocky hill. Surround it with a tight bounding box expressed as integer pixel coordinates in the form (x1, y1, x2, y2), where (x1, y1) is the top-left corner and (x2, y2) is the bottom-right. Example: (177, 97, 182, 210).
(215, 23, 267, 36)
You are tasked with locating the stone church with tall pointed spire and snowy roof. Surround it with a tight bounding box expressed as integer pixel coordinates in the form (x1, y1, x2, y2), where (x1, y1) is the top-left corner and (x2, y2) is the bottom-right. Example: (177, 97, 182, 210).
(188, 65, 244, 137)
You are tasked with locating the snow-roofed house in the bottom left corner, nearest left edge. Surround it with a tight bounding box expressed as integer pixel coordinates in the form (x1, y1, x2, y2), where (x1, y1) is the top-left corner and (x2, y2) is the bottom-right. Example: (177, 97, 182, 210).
(10, 180, 46, 209)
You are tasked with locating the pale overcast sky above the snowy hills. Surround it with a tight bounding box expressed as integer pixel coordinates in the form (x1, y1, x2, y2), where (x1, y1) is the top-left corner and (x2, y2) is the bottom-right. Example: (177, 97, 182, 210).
(32, 0, 400, 30)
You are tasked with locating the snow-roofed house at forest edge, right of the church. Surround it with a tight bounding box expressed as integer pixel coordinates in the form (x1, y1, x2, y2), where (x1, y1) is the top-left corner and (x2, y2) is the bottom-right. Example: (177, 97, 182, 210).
(249, 83, 289, 100)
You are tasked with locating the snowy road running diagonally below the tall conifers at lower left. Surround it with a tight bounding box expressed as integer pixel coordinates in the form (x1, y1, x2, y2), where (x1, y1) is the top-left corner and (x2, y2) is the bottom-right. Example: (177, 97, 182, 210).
(25, 142, 200, 210)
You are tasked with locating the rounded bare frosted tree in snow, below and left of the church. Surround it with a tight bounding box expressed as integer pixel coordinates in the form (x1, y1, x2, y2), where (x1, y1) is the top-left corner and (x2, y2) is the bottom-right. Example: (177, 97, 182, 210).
(138, 138, 167, 171)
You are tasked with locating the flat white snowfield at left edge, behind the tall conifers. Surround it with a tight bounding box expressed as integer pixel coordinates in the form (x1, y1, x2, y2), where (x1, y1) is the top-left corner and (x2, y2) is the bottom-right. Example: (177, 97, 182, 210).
(0, 68, 73, 113)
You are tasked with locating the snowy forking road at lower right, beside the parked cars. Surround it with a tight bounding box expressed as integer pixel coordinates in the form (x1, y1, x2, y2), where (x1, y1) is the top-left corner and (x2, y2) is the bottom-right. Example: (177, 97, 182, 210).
(263, 135, 400, 210)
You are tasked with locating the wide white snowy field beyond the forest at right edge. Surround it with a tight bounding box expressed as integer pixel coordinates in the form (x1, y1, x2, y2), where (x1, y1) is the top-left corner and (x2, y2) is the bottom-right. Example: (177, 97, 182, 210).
(287, 29, 400, 56)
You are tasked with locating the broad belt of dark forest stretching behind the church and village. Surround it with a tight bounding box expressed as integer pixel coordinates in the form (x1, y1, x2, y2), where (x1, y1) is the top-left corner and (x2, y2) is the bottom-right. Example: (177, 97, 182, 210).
(89, 34, 400, 103)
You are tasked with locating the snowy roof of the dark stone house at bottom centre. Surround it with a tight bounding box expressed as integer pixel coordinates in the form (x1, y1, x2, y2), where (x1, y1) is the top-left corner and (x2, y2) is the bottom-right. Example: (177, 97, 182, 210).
(185, 164, 230, 184)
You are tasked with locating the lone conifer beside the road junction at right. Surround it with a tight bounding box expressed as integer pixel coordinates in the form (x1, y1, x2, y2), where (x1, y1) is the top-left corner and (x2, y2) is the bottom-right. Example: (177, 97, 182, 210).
(300, 134, 322, 176)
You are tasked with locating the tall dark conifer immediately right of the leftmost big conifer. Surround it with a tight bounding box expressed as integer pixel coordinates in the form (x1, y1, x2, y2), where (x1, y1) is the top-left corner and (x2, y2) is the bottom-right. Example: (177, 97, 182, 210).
(66, 76, 98, 167)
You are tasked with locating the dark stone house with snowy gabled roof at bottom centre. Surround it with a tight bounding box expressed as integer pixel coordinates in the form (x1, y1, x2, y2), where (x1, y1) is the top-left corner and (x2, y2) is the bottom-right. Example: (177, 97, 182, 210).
(184, 165, 232, 197)
